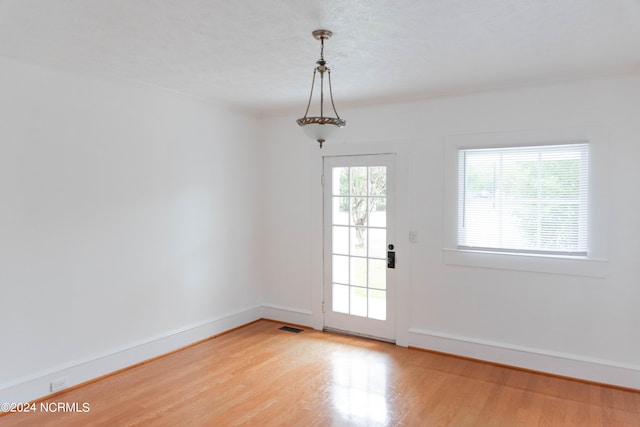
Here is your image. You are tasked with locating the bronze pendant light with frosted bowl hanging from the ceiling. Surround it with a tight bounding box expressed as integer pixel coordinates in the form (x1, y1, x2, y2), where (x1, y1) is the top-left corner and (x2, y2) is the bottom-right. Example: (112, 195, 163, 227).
(296, 30, 347, 148)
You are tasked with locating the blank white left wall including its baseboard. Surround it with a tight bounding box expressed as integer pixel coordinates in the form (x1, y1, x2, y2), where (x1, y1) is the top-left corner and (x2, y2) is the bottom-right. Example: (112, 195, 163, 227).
(0, 56, 262, 401)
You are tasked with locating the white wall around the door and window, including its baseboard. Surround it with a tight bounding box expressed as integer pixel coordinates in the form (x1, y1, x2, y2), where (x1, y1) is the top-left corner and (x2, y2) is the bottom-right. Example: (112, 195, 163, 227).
(263, 76, 640, 388)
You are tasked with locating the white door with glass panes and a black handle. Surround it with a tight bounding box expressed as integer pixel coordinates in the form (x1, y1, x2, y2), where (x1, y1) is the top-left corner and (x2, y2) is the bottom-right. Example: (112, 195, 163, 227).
(323, 154, 395, 341)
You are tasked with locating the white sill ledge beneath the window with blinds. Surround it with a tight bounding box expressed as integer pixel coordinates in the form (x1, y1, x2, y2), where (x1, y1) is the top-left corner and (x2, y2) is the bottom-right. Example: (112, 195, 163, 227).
(443, 248, 608, 278)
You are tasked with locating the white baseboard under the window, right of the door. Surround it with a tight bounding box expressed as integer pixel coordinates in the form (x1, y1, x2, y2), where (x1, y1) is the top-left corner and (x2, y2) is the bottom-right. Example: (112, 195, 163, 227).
(409, 328, 640, 390)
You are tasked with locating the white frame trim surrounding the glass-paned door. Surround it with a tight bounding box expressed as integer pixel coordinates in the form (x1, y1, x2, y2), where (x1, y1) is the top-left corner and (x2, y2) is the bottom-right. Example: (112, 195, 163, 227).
(308, 140, 412, 347)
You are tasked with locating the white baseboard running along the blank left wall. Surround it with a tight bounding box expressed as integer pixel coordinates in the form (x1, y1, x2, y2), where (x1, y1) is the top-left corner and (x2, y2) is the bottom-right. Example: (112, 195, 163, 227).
(0, 306, 262, 403)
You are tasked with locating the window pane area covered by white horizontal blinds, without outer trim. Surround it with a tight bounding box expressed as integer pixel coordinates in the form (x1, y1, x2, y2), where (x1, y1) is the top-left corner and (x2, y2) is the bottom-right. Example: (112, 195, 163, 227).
(457, 143, 589, 257)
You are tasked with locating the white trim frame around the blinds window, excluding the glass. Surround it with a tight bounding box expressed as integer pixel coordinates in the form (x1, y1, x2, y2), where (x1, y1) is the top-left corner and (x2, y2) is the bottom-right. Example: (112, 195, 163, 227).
(443, 127, 609, 277)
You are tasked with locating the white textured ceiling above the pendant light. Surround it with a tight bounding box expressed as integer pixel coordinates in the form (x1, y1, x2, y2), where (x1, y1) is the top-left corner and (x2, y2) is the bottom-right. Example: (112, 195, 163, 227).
(0, 0, 640, 113)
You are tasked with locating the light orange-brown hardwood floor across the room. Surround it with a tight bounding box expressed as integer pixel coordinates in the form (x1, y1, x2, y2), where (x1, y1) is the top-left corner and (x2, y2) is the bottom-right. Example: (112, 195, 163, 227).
(0, 320, 640, 427)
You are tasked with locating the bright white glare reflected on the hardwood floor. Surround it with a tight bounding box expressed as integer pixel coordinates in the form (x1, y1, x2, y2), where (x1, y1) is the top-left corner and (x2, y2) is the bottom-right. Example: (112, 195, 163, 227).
(331, 353, 389, 425)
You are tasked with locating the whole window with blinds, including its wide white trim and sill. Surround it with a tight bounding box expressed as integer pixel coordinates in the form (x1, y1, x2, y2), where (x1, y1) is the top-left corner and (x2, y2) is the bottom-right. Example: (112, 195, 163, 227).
(442, 126, 611, 278)
